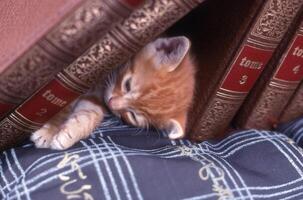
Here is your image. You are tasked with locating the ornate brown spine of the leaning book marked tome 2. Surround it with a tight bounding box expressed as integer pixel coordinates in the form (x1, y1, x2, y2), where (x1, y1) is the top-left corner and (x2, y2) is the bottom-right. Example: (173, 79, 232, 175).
(0, 0, 203, 150)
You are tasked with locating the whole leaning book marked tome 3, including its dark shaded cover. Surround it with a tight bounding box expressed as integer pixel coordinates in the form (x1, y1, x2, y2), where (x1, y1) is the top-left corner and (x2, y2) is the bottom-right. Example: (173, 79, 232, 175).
(188, 0, 303, 140)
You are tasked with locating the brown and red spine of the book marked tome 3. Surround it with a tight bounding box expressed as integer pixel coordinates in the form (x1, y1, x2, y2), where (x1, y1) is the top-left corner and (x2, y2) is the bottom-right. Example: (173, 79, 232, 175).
(190, 0, 303, 140)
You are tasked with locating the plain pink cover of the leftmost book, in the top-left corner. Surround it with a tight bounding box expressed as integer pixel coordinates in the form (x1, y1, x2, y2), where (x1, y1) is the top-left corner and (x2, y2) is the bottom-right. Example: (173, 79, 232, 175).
(0, 0, 84, 74)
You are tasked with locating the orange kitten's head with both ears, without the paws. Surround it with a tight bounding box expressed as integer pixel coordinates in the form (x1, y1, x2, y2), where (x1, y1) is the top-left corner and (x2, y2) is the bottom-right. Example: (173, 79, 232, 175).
(105, 37, 195, 137)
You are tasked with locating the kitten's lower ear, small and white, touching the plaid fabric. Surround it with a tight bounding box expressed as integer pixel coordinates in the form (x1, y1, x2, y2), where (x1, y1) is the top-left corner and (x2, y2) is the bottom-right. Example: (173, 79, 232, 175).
(167, 113, 186, 140)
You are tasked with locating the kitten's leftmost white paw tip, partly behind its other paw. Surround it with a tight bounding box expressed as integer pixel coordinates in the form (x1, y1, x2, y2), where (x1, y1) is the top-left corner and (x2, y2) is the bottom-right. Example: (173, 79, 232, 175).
(30, 127, 56, 148)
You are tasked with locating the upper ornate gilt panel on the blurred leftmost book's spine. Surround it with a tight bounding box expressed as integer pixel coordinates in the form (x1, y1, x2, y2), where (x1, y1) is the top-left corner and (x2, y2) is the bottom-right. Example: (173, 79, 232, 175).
(45, 0, 131, 58)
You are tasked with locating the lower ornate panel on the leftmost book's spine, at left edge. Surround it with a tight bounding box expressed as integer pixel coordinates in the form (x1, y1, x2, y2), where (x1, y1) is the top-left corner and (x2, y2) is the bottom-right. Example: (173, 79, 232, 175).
(0, 46, 65, 101)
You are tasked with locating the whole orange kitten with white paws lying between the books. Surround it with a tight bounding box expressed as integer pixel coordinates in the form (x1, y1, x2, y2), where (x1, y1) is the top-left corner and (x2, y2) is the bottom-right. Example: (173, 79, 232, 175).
(31, 36, 195, 149)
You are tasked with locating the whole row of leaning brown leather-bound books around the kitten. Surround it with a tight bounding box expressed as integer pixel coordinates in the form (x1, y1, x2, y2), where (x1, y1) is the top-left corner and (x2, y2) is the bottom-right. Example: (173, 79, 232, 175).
(0, 0, 303, 150)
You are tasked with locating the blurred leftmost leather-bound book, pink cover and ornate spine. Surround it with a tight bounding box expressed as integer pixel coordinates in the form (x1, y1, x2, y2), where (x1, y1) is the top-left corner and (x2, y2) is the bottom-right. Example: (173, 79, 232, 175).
(0, 0, 143, 119)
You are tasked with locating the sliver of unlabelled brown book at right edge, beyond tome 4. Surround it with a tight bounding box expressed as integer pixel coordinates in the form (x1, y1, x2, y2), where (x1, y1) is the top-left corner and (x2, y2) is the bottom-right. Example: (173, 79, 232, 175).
(279, 81, 303, 123)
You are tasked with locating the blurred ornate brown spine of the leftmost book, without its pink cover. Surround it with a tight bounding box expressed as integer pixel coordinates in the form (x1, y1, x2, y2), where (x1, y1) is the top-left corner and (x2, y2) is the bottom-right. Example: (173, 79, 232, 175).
(0, 0, 143, 119)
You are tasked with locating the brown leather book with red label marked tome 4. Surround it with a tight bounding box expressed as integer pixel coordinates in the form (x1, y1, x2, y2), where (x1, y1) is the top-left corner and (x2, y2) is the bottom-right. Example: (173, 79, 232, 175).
(234, 17, 303, 129)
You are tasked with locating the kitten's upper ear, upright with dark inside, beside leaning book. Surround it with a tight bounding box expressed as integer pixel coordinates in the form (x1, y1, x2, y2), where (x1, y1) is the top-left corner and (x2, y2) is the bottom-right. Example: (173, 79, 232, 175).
(145, 36, 190, 72)
